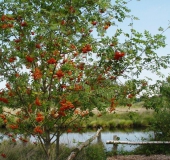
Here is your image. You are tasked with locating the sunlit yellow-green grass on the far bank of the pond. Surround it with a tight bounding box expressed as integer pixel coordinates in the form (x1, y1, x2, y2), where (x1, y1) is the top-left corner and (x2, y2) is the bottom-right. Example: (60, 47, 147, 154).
(82, 103, 153, 129)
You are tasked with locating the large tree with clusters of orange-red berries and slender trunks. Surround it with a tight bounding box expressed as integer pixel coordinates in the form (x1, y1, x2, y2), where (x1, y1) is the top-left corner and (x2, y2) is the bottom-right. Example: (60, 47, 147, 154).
(0, 0, 169, 159)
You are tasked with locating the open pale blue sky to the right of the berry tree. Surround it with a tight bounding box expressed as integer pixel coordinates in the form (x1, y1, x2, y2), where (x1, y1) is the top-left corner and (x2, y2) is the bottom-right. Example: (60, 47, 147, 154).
(108, 0, 170, 83)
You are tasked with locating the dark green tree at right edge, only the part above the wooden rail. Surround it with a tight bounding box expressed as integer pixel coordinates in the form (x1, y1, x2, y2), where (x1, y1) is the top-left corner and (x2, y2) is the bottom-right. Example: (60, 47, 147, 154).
(144, 77, 170, 140)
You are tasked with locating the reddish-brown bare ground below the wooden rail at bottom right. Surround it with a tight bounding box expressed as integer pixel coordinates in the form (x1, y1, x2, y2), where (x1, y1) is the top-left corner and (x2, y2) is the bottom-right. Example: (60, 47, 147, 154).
(107, 155, 170, 160)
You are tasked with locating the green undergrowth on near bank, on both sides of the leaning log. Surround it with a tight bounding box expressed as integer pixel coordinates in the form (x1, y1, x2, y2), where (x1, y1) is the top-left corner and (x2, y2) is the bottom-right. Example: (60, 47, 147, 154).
(0, 140, 106, 160)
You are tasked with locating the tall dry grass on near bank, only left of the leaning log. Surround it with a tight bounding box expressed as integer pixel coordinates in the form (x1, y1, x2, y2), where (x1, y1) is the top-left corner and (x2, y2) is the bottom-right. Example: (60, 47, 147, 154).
(0, 140, 74, 160)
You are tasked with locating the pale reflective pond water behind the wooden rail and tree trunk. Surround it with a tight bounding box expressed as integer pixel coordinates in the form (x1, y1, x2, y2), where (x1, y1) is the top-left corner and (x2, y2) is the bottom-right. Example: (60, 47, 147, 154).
(1, 130, 154, 151)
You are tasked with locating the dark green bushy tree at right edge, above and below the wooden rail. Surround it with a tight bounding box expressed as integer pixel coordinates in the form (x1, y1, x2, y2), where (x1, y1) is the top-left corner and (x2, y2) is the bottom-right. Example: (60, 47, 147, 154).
(133, 77, 170, 155)
